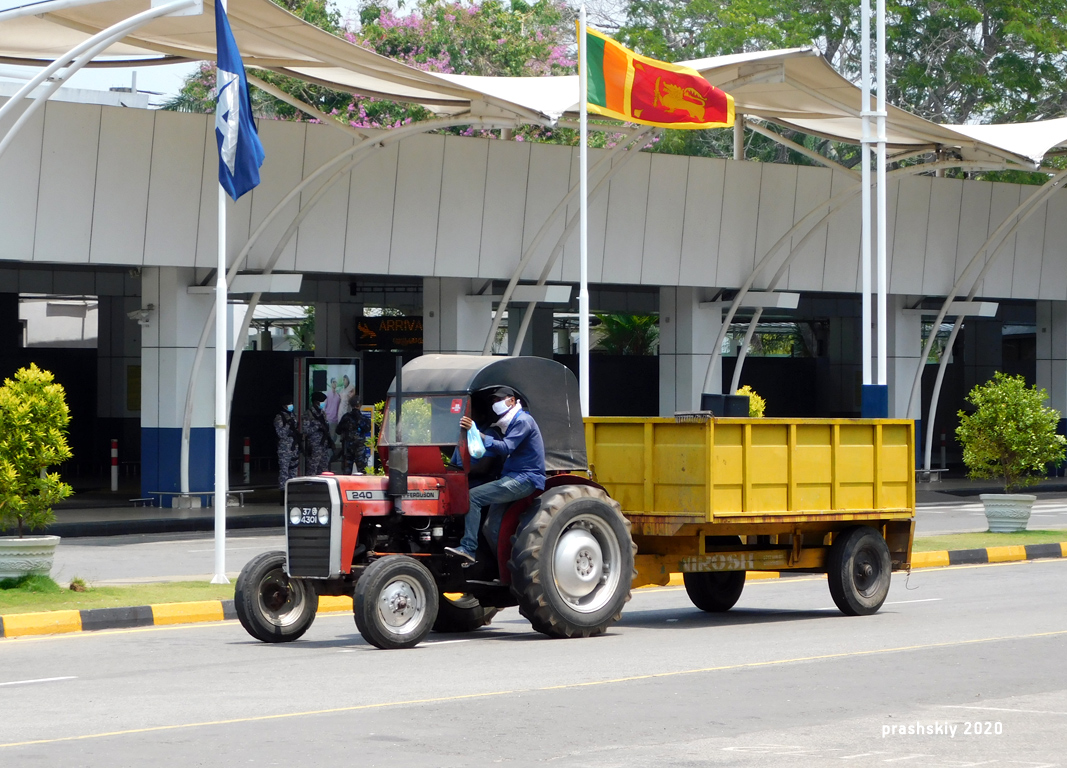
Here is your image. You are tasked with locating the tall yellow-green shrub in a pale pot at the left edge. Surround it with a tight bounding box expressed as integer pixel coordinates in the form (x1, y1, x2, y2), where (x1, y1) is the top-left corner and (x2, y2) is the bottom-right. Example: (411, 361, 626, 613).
(0, 363, 71, 578)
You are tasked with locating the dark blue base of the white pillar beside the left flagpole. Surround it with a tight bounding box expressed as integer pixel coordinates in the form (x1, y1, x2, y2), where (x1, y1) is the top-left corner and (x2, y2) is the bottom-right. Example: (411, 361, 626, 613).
(141, 427, 214, 506)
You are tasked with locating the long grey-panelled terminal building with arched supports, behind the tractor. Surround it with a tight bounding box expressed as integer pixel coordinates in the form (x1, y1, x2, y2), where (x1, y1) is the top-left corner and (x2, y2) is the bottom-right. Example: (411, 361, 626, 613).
(0, 0, 1067, 492)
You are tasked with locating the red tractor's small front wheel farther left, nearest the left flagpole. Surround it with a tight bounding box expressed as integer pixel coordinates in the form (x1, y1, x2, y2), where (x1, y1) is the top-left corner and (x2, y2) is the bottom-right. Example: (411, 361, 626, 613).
(234, 551, 319, 642)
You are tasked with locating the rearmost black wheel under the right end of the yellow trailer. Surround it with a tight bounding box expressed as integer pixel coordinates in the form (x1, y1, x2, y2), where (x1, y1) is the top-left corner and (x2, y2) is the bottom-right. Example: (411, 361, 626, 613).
(826, 526, 893, 615)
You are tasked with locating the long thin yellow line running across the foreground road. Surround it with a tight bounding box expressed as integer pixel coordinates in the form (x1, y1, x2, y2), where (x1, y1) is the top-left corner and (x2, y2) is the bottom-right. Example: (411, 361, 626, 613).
(8, 629, 1067, 749)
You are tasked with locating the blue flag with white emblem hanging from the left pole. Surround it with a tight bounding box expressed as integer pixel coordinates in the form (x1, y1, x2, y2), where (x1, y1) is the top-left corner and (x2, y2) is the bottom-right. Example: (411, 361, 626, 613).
(214, 0, 265, 201)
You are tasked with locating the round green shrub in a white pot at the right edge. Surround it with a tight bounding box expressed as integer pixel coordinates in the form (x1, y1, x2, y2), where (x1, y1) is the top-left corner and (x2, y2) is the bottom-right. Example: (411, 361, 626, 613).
(956, 371, 1067, 532)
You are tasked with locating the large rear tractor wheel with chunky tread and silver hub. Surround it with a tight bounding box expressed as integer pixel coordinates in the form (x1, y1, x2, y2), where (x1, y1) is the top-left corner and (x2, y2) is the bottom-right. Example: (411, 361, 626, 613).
(508, 485, 637, 637)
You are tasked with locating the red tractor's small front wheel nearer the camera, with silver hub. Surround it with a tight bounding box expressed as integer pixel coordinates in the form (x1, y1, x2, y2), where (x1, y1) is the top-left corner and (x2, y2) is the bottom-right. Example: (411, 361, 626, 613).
(352, 555, 437, 650)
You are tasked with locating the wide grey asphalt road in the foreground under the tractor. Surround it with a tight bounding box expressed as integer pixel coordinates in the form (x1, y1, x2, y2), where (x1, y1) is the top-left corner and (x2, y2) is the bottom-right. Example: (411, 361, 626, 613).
(0, 560, 1067, 768)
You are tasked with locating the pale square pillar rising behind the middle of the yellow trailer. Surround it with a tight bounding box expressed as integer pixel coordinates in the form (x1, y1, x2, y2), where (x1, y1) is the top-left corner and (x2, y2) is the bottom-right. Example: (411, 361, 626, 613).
(659, 287, 722, 416)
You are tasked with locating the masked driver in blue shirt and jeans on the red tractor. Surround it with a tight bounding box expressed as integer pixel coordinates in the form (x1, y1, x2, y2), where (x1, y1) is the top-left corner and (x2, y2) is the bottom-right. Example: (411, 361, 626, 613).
(445, 386, 545, 564)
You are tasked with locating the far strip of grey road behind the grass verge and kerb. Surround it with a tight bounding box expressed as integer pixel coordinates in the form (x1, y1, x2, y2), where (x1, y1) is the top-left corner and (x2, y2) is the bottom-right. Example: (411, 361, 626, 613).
(52, 498, 1067, 583)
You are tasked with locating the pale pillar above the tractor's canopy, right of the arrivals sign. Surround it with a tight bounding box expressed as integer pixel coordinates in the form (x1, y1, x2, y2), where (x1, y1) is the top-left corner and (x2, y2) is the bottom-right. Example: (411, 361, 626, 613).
(423, 277, 493, 354)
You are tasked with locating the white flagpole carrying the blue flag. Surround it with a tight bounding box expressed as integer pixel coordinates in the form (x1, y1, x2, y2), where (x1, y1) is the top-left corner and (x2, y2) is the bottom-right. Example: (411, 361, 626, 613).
(211, 0, 236, 583)
